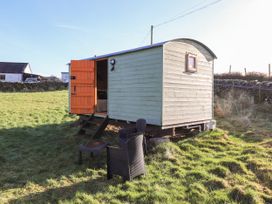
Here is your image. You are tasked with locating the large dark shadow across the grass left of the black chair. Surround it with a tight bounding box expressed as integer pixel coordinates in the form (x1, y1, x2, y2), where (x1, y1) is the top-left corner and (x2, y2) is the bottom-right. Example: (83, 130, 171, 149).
(0, 123, 119, 194)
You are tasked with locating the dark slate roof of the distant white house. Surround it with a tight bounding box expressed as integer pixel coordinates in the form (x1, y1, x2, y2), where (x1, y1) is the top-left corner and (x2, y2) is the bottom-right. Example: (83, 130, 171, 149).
(0, 62, 28, 74)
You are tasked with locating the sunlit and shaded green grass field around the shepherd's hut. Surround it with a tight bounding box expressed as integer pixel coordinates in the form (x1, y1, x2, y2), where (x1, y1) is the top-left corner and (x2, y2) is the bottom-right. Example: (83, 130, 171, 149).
(0, 91, 272, 203)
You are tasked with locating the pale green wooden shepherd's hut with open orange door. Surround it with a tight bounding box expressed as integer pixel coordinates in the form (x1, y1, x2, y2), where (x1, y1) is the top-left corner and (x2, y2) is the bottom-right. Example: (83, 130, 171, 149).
(69, 38, 216, 129)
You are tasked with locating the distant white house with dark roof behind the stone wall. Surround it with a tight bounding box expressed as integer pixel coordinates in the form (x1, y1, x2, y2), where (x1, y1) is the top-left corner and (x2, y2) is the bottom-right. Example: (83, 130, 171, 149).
(0, 62, 32, 82)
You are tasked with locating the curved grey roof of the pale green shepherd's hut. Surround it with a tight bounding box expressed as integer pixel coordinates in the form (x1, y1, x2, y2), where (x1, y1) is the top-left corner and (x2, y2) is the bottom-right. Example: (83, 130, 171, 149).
(84, 38, 217, 60)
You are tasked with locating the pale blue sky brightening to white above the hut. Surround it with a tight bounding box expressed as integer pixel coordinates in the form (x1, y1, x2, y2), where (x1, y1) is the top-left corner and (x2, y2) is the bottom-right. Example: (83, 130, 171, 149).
(0, 0, 272, 76)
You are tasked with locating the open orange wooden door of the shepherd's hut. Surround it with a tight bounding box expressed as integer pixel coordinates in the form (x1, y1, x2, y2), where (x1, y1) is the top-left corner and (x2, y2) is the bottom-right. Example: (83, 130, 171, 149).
(70, 60, 95, 114)
